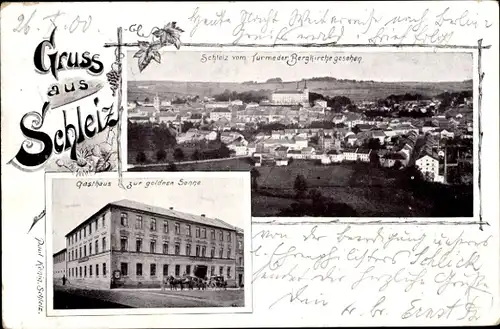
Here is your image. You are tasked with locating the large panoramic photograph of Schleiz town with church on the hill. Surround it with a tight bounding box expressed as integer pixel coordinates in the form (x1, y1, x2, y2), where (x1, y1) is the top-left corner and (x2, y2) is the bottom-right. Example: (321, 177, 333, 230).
(127, 52, 474, 217)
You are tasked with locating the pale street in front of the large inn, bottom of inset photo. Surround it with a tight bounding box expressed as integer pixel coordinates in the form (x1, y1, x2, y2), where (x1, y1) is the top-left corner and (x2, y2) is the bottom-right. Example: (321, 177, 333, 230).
(54, 285, 244, 309)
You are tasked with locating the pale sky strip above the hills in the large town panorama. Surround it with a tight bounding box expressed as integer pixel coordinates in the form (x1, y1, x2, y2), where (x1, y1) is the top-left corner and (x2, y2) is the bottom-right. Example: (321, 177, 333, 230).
(127, 50, 473, 82)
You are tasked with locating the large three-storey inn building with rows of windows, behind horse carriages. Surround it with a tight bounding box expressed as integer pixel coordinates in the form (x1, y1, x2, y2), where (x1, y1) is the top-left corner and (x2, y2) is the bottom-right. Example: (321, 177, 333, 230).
(66, 200, 243, 288)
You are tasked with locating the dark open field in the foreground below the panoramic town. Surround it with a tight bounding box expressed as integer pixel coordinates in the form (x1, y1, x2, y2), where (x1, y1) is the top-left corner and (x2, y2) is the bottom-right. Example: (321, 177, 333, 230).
(131, 159, 473, 217)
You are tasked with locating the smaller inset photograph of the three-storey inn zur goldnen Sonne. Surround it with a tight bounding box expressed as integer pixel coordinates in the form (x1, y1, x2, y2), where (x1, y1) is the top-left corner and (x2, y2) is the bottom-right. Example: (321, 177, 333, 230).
(51, 175, 250, 310)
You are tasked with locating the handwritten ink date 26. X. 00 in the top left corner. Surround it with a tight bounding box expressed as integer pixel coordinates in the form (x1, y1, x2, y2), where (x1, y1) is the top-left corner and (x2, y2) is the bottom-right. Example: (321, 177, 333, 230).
(12, 9, 92, 36)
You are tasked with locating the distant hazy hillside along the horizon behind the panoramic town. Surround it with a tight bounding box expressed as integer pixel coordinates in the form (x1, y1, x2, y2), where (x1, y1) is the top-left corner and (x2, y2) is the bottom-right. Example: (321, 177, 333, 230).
(127, 79, 473, 101)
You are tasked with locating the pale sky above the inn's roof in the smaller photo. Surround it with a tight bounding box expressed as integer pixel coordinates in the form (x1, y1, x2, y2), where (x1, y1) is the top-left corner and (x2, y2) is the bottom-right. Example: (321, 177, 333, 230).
(49, 176, 251, 253)
